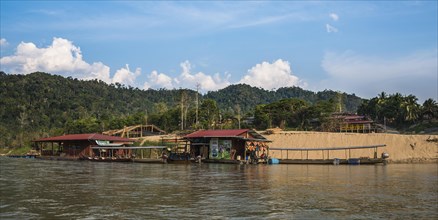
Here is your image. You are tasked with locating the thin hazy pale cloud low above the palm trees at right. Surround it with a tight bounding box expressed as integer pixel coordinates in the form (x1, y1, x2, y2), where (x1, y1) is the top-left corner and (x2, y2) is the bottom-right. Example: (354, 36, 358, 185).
(319, 49, 438, 100)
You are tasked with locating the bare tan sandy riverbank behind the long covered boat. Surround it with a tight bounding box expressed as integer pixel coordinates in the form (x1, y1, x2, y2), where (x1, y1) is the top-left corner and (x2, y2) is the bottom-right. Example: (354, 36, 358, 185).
(264, 131, 438, 163)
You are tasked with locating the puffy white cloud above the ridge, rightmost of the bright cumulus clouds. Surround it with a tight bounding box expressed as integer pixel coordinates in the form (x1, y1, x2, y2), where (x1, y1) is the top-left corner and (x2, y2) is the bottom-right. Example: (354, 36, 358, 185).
(239, 59, 302, 90)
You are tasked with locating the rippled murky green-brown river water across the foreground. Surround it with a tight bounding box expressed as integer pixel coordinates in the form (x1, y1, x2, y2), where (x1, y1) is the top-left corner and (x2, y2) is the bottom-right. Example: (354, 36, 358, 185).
(0, 157, 438, 219)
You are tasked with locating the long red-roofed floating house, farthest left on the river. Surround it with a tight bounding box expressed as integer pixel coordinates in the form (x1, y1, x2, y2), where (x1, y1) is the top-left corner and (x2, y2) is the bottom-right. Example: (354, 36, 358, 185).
(33, 133, 134, 159)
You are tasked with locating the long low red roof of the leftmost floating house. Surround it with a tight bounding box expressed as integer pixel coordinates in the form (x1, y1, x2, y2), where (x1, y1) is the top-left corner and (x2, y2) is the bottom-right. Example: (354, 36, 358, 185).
(34, 133, 133, 142)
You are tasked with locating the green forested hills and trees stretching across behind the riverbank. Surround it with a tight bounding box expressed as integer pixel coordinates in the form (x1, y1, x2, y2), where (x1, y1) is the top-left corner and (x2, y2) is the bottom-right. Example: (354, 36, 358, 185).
(0, 72, 438, 147)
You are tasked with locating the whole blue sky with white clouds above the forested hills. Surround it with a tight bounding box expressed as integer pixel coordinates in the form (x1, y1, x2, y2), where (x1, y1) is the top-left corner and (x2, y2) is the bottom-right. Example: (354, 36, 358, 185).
(0, 0, 438, 102)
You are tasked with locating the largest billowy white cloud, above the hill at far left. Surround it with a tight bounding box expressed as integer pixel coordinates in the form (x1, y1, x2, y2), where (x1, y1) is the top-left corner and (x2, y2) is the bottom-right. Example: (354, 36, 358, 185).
(0, 38, 111, 83)
